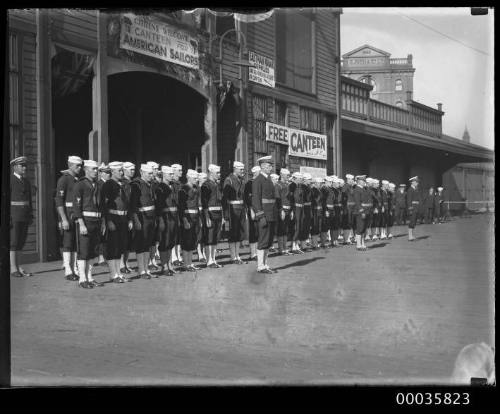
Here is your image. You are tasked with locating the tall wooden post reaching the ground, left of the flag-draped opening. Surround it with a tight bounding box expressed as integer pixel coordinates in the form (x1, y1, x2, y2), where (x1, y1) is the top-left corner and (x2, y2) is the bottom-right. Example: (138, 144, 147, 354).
(36, 9, 57, 261)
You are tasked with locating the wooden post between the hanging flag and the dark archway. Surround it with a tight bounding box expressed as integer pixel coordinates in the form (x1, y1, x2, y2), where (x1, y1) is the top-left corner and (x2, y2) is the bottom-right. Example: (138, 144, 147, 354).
(89, 11, 109, 163)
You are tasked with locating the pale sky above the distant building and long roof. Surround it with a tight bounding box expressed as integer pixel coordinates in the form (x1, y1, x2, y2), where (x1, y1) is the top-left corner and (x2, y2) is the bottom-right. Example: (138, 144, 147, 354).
(340, 7, 494, 149)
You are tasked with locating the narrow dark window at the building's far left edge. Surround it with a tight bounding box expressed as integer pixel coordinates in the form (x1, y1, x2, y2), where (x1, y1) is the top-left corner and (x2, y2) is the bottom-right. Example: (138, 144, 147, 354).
(9, 32, 23, 159)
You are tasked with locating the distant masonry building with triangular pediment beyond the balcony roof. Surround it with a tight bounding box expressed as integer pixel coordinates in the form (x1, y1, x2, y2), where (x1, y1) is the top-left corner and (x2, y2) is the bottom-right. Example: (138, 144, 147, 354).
(342, 45, 415, 108)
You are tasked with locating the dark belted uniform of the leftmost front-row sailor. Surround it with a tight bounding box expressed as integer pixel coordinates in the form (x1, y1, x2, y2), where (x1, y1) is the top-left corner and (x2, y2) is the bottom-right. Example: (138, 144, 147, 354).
(73, 177, 104, 260)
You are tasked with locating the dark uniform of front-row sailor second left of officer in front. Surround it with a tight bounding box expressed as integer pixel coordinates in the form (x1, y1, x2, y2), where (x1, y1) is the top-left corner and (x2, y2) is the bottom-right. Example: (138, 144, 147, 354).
(200, 179, 222, 246)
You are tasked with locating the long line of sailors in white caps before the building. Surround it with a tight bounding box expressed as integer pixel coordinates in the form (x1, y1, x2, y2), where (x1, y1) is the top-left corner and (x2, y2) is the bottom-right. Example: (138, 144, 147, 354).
(7, 156, 446, 288)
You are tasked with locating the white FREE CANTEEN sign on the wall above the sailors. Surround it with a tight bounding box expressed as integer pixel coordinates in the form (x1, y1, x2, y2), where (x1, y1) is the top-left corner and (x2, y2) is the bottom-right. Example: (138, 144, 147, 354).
(266, 122, 327, 160)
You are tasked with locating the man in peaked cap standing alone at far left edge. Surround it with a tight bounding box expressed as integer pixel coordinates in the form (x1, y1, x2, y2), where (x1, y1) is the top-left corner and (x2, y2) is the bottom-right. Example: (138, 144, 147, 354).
(10, 156, 33, 277)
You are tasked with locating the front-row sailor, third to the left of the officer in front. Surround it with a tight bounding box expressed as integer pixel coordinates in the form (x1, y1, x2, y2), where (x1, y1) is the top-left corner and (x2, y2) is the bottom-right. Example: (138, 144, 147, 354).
(179, 169, 200, 272)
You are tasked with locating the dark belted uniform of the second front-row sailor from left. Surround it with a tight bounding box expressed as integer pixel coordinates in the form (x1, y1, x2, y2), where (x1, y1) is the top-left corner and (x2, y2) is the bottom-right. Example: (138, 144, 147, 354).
(101, 178, 132, 260)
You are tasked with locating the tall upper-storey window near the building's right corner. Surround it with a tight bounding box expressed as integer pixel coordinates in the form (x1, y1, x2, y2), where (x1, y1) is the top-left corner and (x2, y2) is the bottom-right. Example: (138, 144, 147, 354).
(276, 10, 314, 93)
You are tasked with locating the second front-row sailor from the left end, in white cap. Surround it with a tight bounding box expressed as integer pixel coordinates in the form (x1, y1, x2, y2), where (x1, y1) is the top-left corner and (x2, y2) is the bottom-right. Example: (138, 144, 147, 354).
(101, 161, 133, 283)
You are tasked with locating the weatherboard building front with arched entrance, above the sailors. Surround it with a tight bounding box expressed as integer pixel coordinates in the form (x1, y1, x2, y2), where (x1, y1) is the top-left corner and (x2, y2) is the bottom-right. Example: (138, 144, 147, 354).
(8, 8, 341, 261)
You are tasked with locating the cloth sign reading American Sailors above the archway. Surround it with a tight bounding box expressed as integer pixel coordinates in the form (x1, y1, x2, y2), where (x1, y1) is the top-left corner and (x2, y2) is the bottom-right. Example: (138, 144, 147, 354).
(120, 13, 200, 69)
